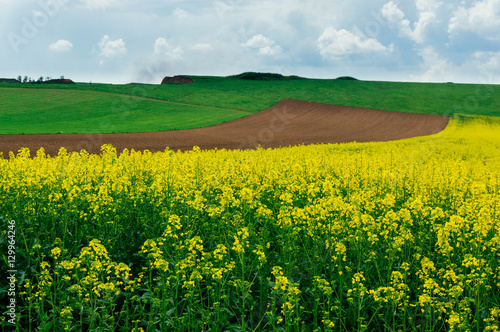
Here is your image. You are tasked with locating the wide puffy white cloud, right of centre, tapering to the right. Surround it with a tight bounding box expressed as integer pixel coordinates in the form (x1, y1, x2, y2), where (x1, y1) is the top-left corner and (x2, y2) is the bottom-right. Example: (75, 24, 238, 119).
(318, 27, 392, 58)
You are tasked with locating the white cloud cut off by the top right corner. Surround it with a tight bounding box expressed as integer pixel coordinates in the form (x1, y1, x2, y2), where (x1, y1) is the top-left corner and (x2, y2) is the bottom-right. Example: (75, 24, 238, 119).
(448, 0, 500, 40)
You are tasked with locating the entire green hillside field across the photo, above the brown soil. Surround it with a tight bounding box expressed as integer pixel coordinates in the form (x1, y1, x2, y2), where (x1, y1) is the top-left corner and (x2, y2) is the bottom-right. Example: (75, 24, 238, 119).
(0, 76, 500, 134)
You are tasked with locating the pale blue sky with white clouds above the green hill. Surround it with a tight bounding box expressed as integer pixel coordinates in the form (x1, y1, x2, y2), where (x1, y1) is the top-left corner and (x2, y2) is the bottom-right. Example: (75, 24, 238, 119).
(0, 0, 500, 84)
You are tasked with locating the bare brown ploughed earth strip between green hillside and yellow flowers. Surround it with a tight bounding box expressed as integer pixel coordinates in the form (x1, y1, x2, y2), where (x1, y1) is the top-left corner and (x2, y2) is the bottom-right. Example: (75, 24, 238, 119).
(0, 99, 449, 157)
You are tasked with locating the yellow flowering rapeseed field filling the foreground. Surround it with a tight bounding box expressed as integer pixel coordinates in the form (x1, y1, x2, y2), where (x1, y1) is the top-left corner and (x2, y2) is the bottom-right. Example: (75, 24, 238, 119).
(0, 117, 500, 331)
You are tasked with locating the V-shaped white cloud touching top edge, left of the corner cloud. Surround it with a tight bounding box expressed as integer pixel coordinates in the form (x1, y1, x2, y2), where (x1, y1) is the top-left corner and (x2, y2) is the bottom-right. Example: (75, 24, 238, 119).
(381, 0, 443, 44)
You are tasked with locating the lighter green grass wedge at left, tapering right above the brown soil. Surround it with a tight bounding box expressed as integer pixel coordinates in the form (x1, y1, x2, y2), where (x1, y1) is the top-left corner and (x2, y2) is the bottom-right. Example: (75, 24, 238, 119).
(0, 88, 247, 134)
